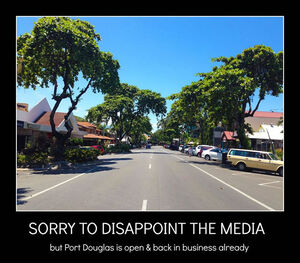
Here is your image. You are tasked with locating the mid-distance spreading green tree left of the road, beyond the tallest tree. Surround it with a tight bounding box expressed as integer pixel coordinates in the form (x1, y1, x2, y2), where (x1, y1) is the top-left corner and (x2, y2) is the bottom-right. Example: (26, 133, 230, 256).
(87, 83, 166, 142)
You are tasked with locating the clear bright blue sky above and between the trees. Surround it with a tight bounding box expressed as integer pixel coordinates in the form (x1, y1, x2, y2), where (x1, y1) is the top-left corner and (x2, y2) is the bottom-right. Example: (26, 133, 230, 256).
(17, 17, 284, 130)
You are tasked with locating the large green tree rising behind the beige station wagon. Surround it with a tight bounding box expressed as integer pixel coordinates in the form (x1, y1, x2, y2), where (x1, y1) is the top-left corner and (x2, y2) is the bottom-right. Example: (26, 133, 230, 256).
(205, 45, 283, 147)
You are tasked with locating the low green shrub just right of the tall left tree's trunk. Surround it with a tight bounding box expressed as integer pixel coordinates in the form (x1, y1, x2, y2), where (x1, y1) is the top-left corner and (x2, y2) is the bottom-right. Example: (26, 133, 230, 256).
(65, 148, 99, 163)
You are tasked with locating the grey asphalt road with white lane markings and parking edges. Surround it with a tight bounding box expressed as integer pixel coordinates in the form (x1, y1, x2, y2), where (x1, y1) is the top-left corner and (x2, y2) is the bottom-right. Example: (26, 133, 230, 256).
(16, 146, 284, 211)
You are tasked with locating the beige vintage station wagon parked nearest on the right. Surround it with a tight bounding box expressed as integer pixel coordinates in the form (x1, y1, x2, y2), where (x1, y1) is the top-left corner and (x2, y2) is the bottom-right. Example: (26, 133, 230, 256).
(227, 149, 283, 176)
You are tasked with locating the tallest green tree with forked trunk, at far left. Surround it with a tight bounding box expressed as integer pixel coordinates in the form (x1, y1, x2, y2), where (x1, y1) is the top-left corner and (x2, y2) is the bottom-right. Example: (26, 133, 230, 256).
(17, 17, 120, 159)
